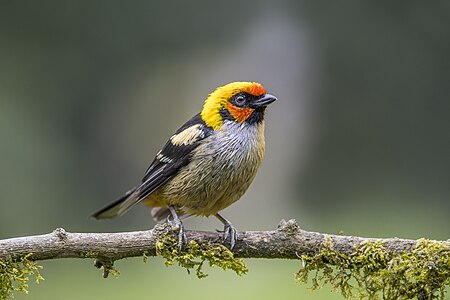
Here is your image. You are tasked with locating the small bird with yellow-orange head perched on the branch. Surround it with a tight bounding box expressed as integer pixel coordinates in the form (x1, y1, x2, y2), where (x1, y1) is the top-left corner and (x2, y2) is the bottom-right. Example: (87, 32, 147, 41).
(92, 82, 277, 251)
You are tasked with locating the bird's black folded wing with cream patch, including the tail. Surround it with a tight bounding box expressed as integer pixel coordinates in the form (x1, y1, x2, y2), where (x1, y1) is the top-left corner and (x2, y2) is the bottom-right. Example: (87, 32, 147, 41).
(93, 114, 213, 219)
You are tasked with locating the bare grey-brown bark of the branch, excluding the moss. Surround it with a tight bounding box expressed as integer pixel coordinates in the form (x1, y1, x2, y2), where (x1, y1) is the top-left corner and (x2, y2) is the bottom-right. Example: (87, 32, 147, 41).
(0, 220, 442, 261)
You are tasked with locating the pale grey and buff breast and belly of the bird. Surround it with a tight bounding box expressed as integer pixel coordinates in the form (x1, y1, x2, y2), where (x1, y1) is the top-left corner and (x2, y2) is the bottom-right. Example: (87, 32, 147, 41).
(164, 121, 264, 215)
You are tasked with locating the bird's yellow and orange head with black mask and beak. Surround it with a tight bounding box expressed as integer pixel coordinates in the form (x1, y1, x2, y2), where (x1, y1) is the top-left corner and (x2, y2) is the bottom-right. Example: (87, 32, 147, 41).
(201, 82, 277, 130)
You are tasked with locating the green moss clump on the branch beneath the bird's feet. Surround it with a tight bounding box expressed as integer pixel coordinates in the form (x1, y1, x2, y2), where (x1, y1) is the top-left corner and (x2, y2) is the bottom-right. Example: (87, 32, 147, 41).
(156, 236, 248, 278)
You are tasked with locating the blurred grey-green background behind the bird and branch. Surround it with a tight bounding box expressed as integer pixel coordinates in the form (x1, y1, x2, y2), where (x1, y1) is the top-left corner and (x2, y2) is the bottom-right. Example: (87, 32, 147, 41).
(0, 0, 450, 299)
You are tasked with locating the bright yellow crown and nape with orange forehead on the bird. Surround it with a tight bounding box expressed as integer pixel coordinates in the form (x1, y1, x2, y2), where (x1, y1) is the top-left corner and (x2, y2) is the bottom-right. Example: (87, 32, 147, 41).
(201, 82, 266, 130)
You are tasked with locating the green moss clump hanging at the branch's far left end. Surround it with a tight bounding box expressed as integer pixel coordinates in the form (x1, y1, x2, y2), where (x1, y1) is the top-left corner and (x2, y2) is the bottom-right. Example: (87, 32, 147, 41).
(0, 253, 44, 300)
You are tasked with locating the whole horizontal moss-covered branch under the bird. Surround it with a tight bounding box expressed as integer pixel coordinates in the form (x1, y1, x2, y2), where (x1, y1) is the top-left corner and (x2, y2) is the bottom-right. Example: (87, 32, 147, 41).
(0, 220, 450, 299)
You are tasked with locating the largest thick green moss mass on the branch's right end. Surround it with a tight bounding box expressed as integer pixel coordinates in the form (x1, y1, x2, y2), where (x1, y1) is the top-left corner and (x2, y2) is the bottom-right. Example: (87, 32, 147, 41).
(296, 239, 450, 300)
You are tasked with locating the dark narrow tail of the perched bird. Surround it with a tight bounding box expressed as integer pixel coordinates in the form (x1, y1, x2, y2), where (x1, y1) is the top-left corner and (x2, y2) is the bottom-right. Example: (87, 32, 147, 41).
(91, 188, 139, 219)
